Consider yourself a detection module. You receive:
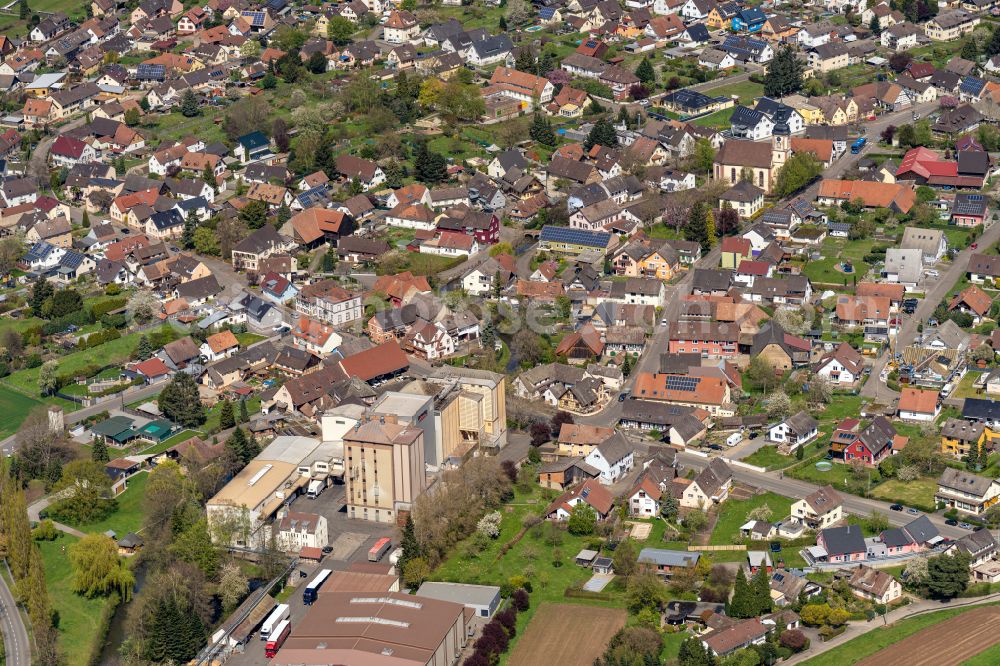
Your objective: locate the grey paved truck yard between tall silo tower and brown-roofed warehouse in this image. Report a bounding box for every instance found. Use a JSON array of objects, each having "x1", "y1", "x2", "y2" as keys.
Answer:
[{"x1": 226, "y1": 485, "x2": 399, "y2": 666}]
